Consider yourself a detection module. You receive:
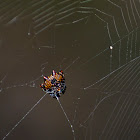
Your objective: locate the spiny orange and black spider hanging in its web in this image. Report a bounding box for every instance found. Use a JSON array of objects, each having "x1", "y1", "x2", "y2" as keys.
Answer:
[{"x1": 40, "y1": 70, "x2": 66, "y2": 98}]
